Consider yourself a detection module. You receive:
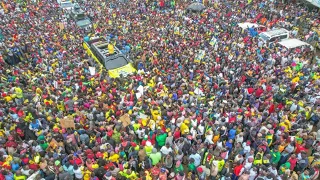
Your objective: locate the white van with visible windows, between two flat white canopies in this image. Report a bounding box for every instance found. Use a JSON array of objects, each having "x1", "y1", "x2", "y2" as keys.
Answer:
[{"x1": 259, "y1": 28, "x2": 290, "y2": 42}]
